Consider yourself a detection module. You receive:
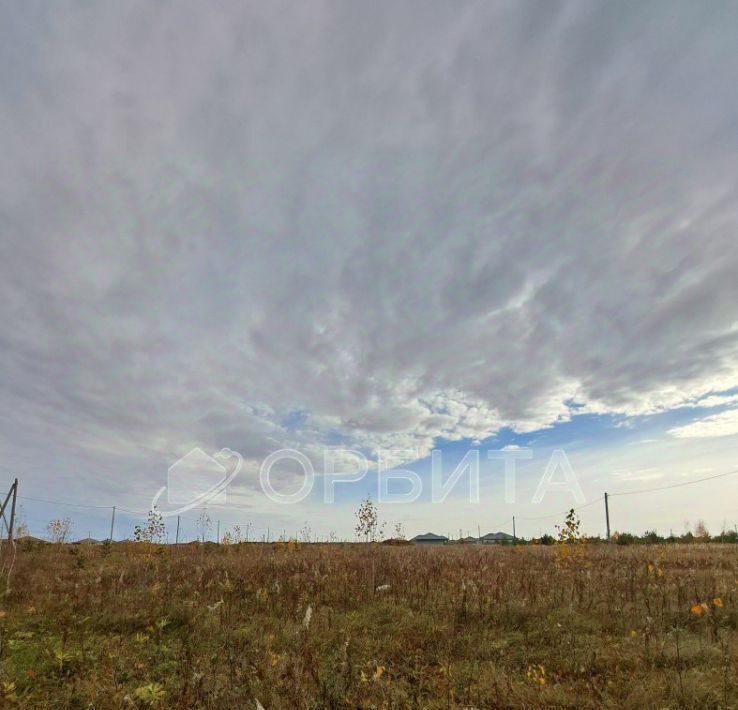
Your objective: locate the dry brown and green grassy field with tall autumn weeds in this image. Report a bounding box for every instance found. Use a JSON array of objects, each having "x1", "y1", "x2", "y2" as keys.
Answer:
[{"x1": 0, "y1": 543, "x2": 738, "y2": 710}]
